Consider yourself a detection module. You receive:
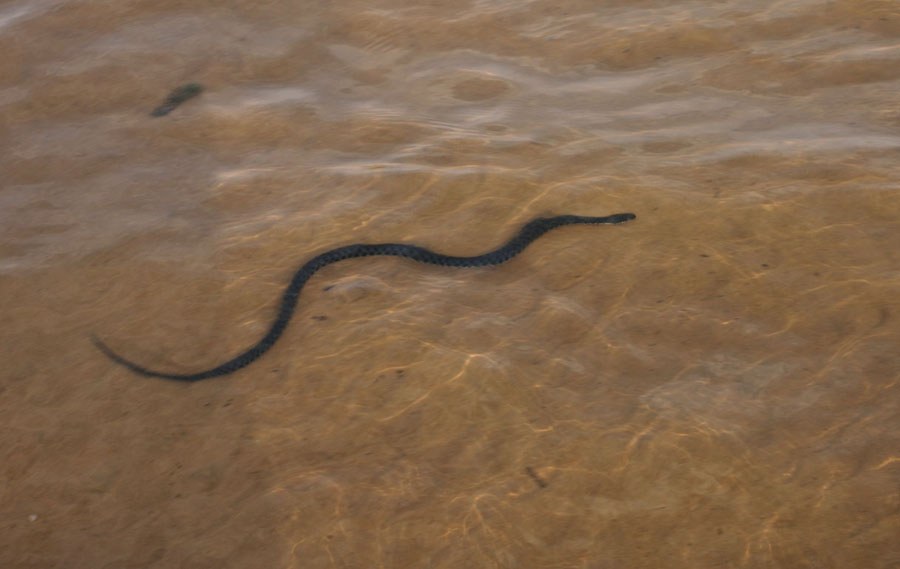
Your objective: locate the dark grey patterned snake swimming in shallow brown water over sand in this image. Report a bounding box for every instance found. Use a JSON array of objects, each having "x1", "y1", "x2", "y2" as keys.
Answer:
[{"x1": 91, "y1": 213, "x2": 636, "y2": 382}]
